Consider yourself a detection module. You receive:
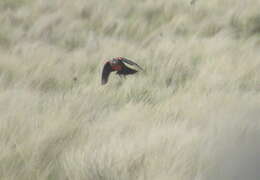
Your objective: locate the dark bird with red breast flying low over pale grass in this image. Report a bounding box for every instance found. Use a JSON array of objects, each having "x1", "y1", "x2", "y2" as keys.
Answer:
[{"x1": 101, "y1": 57, "x2": 143, "y2": 85}]
